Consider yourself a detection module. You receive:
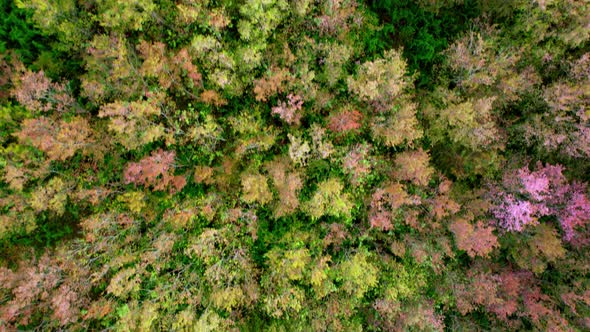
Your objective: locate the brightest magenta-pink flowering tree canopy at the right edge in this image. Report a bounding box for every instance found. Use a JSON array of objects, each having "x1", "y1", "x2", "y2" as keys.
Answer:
[{"x1": 491, "y1": 163, "x2": 590, "y2": 244}]
